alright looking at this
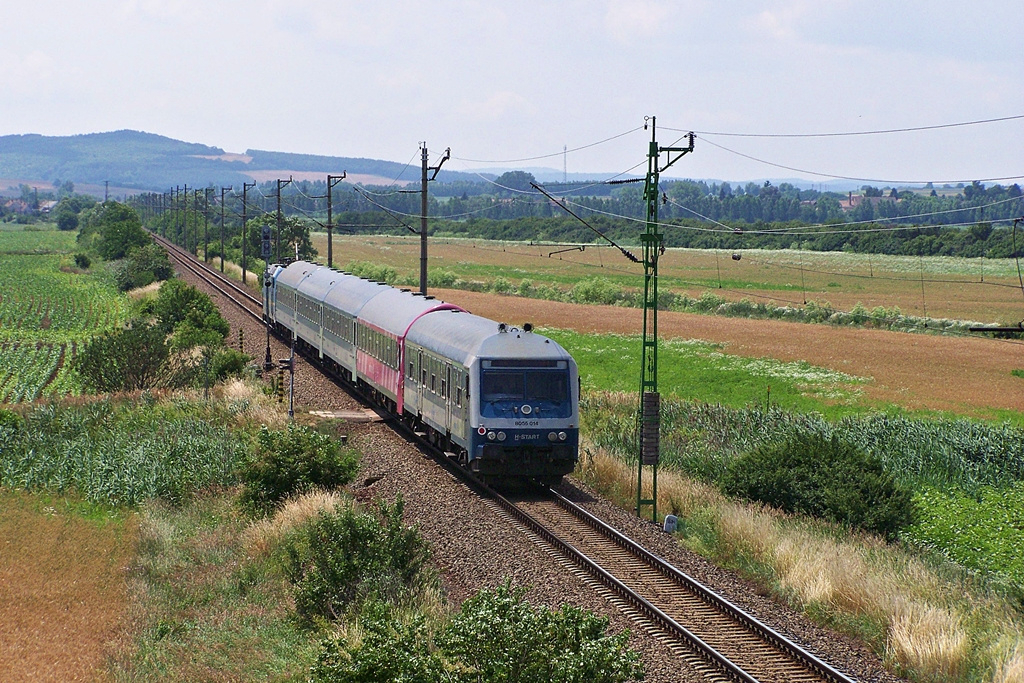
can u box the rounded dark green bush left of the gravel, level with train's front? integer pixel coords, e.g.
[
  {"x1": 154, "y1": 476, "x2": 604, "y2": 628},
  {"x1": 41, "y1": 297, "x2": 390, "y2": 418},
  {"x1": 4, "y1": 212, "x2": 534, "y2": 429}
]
[{"x1": 242, "y1": 425, "x2": 358, "y2": 513}]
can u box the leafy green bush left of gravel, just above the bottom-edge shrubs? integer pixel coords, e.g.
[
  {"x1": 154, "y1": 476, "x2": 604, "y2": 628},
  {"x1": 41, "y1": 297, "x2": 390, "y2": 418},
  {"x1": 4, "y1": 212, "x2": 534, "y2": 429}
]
[{"x1": 287, "y1": 497, "x2": 430, "y2": 622}]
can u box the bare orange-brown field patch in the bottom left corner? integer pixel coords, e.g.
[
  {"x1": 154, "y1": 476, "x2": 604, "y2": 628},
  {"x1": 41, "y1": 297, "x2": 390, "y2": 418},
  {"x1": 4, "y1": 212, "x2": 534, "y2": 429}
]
[{"x1": 0, "y1": 492, "x2": 133, "y2": 683}]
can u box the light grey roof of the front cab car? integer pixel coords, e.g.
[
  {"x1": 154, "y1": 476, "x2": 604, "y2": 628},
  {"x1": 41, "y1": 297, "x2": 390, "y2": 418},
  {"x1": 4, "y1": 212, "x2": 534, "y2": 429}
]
[{"x1": 407, "y1": 311, "x2": 571, "y2": 367}]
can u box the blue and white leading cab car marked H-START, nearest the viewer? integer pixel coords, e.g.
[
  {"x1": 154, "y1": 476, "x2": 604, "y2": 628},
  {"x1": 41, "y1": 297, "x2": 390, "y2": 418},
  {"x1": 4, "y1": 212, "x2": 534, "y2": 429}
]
[{"x1": 406, "y1": 313, "x2": 580, "y2": 485}]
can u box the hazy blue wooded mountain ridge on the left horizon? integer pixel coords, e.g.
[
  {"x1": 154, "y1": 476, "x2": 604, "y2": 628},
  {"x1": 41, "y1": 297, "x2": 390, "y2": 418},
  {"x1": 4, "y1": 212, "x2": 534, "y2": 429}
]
[{"x1": 0, "y1": 130, "x2": 480, "y2": 191}]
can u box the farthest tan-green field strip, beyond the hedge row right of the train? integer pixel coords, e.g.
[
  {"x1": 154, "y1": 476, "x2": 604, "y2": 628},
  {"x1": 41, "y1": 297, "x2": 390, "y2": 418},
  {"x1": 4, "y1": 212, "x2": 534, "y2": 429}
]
[{"x1": 312, "y1": 233, "x2": 1022, "y2": 323}]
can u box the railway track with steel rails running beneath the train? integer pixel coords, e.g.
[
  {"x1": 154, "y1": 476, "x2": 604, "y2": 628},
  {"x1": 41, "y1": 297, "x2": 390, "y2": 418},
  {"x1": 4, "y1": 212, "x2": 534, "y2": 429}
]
[{"x1": 155, "y1": 236, "x2": 854, "y2": 683}]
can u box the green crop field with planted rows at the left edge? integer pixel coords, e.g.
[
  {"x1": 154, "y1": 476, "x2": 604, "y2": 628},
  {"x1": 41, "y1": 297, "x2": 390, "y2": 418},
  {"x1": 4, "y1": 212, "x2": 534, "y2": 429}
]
[{"x1": 0, "y1": 229, "x2": 128, "y2": 403}]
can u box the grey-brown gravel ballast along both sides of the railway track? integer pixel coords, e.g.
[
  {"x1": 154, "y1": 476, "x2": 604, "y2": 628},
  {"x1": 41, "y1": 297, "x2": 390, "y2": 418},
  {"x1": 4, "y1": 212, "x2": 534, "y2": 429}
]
[{"x1": 181, "y1": 272, "x2": 902, "y2": 683}]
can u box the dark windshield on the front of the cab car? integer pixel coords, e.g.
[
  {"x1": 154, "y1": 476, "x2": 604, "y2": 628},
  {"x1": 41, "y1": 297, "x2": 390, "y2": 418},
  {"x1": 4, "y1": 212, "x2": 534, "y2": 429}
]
[{"x1": 480, "y1": 362, "x2": 572, "y2": 419}]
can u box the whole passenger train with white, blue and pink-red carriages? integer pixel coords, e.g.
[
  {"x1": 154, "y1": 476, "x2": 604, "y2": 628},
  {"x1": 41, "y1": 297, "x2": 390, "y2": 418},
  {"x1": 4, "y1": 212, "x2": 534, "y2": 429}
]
[{"x1": 263, "y1": 261, "x2": 580, "y2": 485}]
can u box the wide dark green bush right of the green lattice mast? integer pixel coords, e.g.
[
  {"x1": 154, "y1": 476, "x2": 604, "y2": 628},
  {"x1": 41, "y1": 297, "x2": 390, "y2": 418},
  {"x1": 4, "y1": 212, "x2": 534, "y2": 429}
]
[{"x1": 722, "y1": 433, "x2": 914, "y2": 539}]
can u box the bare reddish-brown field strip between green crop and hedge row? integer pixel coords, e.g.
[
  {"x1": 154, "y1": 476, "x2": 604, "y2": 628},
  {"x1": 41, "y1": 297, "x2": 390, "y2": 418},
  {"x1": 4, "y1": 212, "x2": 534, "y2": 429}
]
[{"x1": 430, "y1": 290, "x2": 1024, "y2": 416}]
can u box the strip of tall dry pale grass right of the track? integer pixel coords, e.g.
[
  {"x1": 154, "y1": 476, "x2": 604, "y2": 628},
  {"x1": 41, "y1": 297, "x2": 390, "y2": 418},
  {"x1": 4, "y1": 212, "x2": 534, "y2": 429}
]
[{"x1": 577, "y1": 446, "x2": 1024, "y2": 683}]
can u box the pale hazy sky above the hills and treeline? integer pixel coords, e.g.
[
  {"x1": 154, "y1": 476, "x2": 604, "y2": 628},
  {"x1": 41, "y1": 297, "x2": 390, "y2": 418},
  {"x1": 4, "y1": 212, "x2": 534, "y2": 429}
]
[{"x1": 0, "y1": 0, "x2": 1024, "y2": 186}]
